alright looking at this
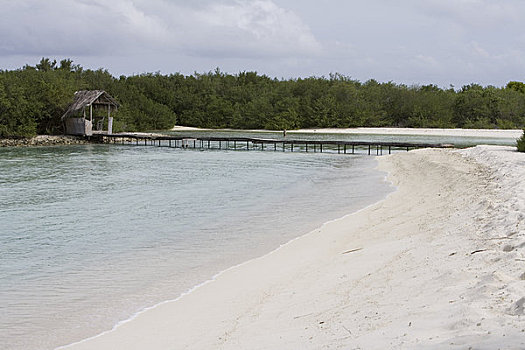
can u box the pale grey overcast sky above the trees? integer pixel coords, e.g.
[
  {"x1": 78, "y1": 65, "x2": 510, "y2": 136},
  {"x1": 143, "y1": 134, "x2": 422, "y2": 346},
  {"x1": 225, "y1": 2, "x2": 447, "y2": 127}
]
[{"x1": 0, "y1": 0, "x2": 525, "y2": 88}]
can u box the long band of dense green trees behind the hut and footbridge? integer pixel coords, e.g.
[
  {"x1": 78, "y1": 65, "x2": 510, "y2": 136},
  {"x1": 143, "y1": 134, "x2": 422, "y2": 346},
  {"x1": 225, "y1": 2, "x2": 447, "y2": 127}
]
[{"x1": 0, "y1": 58, "x2": 525, "y2": 137}]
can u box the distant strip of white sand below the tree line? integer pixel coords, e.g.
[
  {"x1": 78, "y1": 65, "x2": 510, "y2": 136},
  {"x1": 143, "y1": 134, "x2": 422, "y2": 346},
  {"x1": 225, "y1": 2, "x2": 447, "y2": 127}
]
[{"x1": 172, "y1": 126, "x2": 523, "y2": 139}]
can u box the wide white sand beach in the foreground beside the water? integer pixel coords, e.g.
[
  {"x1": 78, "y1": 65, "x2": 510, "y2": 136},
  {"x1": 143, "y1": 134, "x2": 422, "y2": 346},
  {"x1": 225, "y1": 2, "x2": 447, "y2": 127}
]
[{"x1": 62, "y1": 146, "x2": 525, "y2": 350}]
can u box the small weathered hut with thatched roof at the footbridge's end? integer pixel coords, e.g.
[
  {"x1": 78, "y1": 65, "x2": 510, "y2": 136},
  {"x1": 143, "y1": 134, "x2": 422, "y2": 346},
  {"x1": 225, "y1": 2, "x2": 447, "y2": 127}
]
[{"x1": 62, "y1": 90, "x2": 119, "y2": 136}]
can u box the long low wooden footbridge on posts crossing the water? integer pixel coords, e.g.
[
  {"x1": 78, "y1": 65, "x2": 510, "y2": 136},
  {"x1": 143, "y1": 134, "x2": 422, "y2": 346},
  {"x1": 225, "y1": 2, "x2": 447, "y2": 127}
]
[{"x1": 92, "y1": 133, "x2": 454, "y2": 155}]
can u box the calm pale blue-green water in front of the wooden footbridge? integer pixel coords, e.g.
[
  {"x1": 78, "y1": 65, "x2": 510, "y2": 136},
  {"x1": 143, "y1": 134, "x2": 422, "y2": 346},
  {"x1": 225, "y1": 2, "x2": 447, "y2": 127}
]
[{"x1": 0, "y1": 145, "x2": 393, "y2": 350}]
